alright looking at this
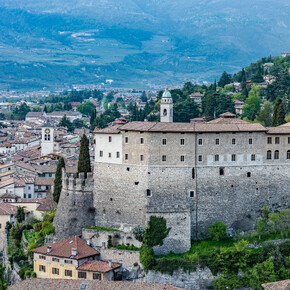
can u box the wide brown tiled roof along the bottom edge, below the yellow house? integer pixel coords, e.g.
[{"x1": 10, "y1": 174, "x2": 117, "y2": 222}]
[{"x1": 8, "y1": 278, "x2": 183, "y2": 290}]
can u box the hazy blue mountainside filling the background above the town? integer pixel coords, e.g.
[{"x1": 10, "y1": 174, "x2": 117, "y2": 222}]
[{"x1": 0, "y1": 0, "x2": 290, "y2": 88}]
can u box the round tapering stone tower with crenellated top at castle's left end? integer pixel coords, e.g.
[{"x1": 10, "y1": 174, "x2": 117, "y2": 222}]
[{"x1": 53, "y1": 170, "x2": 95, "y2": 241}]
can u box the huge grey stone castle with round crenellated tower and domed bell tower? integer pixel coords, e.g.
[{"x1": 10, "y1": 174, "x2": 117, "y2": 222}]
[{"x1": 55, "y1": 90, "x2": 290, "y2": 253}]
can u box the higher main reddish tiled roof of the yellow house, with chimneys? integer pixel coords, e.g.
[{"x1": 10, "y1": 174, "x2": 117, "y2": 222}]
[{"x1": 32, "y1": 236, "x2": 100, "y2": 260}]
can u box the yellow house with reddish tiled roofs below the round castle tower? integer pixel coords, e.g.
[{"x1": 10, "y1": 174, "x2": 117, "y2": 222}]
[{"x1": 32, "y1": 236, "x2": 121, "y2": 280}]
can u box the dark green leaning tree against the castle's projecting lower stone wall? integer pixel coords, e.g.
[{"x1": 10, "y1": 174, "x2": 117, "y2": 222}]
[{"x1": 143, "y1": 216, "x2": 171, "y2": 247}]
